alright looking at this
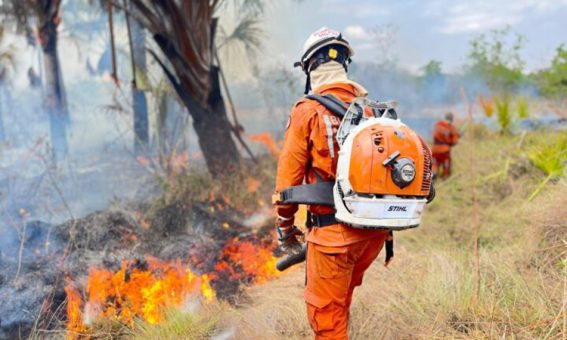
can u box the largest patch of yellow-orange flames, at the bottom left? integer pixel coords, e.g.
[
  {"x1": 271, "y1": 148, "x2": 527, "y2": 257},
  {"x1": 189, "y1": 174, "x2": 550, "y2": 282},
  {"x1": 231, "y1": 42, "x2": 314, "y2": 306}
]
[{"x1": 65, "y1": 257, "x2": 215, "y2": 334}]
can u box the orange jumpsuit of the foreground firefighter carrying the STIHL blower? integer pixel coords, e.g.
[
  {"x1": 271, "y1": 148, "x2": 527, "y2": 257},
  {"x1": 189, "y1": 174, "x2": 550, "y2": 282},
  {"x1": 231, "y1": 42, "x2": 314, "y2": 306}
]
[{"x1": 276, "y1": 83, "x2": 388, "y2": 339}]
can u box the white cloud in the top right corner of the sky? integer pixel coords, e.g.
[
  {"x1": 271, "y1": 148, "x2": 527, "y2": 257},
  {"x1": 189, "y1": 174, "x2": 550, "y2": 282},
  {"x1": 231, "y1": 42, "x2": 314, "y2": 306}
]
[{"x1": 423, "y1": 0, "x2": 567, "y2": 34}]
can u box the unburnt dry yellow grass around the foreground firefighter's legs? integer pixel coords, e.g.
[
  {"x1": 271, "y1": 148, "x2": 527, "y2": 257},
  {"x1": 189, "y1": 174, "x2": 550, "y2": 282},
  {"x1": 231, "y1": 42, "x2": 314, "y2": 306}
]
[{"x1": 129, "y1": 129, "x2": 567, "y2": 339}]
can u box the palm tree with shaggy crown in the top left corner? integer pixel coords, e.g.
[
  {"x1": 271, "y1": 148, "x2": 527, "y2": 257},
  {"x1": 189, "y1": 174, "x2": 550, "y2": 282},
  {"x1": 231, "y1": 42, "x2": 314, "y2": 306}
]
[{"x1": 0, "y1": 0, "x2": 69, "y2": 160}]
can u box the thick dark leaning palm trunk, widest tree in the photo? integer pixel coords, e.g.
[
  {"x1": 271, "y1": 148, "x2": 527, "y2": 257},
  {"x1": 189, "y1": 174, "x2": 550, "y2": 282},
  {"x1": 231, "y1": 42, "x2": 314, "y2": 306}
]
[{"x1": 131, "y1": 0, "x2": 261, "y2": 177}]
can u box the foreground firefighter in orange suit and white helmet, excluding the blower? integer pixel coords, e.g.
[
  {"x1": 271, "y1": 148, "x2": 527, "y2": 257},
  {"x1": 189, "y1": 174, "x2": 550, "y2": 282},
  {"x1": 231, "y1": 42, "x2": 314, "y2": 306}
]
[{"x1": 276, "y1": 27, "x2": 390, "y2": 339}]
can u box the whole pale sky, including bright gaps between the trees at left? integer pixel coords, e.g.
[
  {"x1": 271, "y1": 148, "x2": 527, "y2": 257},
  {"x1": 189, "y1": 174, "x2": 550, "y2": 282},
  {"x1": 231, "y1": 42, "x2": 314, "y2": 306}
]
[{"x1": 2, "y1": 0, "x2": 567, "y2": 88}]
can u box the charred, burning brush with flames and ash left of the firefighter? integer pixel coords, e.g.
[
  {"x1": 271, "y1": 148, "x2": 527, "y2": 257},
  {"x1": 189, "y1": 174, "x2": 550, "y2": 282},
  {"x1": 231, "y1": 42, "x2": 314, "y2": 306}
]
[{"x1": 0, "y1": 157, "x2": 278, "y2": 339}]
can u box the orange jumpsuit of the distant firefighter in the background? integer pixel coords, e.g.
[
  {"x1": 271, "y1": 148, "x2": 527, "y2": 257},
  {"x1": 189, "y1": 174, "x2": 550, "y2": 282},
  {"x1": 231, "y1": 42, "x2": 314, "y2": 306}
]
[{"x1": 431, "y1": 120, "x2": 459, "y2": 178}]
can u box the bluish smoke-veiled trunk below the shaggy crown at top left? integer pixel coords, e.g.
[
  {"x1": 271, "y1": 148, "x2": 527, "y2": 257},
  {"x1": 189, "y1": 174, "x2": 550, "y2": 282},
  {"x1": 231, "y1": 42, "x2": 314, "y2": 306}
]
[{"x1": 41, "y1": 22, "x2": 69, "y2": 161}]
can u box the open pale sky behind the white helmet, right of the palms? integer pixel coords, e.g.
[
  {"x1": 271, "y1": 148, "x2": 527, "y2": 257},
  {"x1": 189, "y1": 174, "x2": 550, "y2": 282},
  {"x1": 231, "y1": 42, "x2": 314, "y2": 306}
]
[{"x1": 264, "y1": 0, "x2": 567, "y2": 73}]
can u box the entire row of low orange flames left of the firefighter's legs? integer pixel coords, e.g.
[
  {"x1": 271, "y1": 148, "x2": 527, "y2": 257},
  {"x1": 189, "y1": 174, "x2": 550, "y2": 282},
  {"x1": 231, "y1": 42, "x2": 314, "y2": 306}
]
[{"x1": 65, "y1": 238, "x2": 278, "y2": 338}]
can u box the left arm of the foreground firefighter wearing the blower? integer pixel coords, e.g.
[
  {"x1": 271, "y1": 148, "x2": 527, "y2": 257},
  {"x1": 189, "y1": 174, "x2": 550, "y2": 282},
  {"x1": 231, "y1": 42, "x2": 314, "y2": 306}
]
[{"x1": 276, "y1": 103, "x2": 313, "y2": 227}]
